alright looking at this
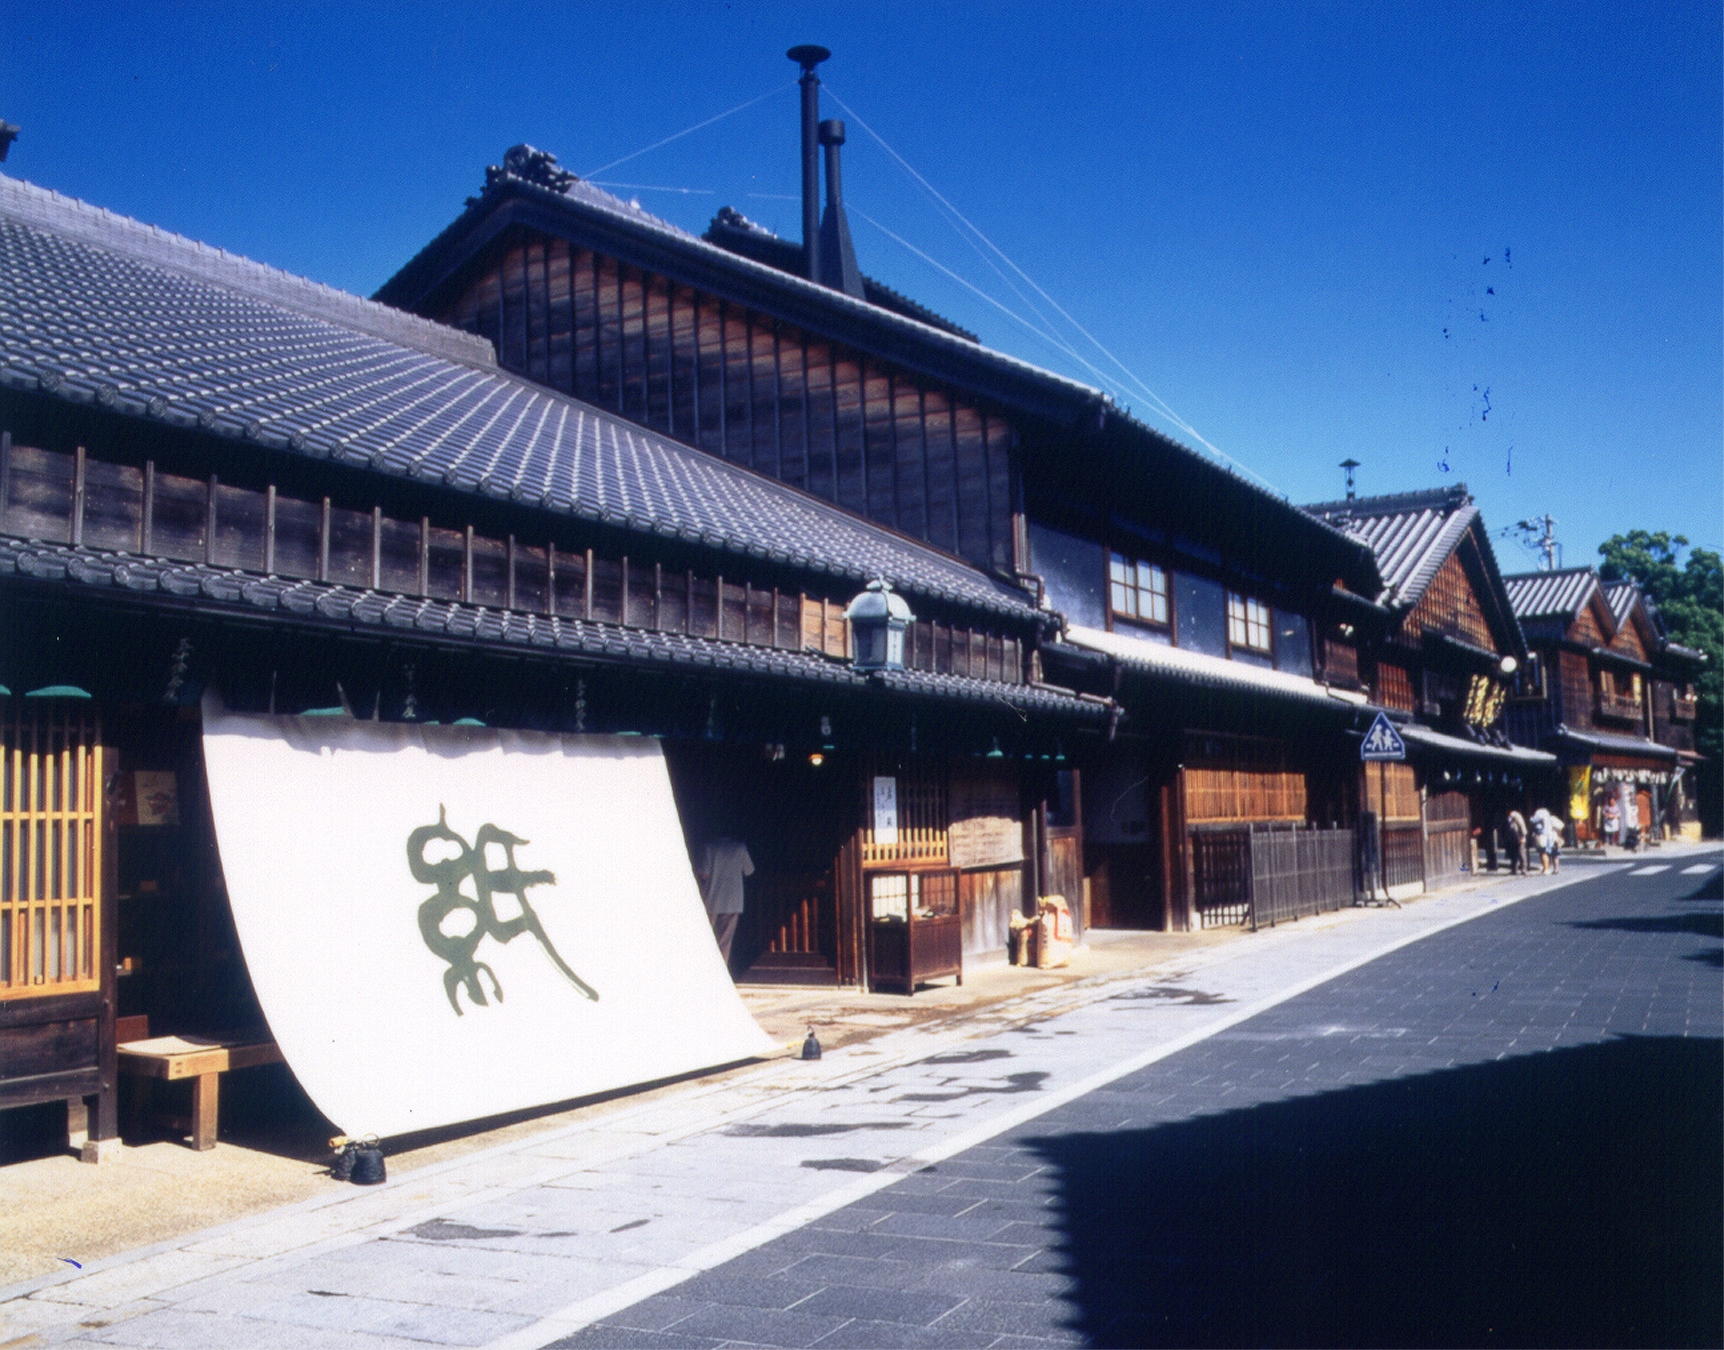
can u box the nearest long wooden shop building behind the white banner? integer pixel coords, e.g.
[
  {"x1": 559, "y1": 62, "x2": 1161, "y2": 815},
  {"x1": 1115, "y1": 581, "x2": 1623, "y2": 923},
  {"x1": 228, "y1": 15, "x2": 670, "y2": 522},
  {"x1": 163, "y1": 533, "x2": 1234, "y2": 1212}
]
[{"x1": 0, "y1": 178, "x2": 1115, "y2": 1158}]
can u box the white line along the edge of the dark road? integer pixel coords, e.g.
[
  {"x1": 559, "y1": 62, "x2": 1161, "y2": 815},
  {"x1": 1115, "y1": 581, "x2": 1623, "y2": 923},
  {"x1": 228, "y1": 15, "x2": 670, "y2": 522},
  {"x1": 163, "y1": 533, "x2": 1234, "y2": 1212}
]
[{"x1": 484, "y1": 872, "x2": 1598, "y2": 1350}]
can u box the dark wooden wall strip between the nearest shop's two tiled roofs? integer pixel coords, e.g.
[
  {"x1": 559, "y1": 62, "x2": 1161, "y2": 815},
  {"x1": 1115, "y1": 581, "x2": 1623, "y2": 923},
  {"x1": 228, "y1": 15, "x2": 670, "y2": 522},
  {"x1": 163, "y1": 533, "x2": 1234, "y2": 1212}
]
[{"x1": 0, "y1": 433, "x2": 1024, "y2": 684}]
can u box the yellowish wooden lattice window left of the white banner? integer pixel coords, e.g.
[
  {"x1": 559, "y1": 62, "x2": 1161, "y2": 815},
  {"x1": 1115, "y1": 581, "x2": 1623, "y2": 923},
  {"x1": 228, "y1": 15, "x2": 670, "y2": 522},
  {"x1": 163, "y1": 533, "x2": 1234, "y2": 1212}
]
[{"x1": 0, "y1": 702, "x2": 103, "y2": 1000}]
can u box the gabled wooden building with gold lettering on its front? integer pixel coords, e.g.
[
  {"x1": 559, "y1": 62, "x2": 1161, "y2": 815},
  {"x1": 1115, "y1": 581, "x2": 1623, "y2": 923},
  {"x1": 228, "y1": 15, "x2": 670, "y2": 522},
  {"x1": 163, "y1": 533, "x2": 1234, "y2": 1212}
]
[{"x1": 1307, "y1": 483, "x2": 1555, "y2": 886}]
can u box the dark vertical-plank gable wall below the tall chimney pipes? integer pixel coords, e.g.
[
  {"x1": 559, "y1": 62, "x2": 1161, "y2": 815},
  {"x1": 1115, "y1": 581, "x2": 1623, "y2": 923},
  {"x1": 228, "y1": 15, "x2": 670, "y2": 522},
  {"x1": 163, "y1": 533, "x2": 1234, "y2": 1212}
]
[{"x1": 429, "y1": 229, "x2": 1014, "y2": 571}]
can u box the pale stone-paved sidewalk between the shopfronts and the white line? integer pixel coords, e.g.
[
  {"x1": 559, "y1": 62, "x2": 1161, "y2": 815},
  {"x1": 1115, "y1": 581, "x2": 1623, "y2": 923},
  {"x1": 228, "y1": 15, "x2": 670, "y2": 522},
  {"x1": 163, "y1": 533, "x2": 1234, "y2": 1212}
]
[{"x1": 0, "y1": 867, "x2": 1710, "y2": 1350}]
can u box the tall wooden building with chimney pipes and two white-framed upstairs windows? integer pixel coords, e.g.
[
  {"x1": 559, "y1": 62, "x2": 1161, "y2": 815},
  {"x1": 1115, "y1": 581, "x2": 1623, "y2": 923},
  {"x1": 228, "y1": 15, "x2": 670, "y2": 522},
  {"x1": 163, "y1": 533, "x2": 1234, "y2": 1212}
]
[{"x1": 376, "y1": 145, "x2": 1381, "y2": 928}]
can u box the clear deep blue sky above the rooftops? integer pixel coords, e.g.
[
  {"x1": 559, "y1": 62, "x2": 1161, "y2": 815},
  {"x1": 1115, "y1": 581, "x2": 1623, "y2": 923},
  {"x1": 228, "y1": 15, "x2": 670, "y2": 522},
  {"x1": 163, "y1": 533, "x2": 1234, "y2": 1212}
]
[{"x1": 0, "y1": 0, "x2": 1724, "y2": 571}]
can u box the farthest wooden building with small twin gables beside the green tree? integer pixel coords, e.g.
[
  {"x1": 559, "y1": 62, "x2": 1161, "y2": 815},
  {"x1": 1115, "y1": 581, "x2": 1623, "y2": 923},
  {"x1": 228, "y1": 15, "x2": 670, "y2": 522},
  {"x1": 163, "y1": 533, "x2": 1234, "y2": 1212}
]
[{"x1": 1507, "y1": 567, "x2": 1681, "y2": 843}]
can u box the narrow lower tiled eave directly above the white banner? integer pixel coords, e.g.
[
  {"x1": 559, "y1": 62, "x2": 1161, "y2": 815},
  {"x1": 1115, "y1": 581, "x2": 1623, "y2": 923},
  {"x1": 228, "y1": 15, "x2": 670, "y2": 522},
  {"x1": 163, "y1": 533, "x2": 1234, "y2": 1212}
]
[{"x1": 0, "y1": 538, "x2": 1107, "y2": 719}]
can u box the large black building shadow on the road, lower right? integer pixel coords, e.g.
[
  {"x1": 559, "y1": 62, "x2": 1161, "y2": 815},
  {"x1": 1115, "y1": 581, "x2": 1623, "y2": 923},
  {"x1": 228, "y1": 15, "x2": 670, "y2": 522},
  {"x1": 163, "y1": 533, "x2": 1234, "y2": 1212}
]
[{"x1": 1026, "y1": 1036, "x2": 1724, "y2": 1347}]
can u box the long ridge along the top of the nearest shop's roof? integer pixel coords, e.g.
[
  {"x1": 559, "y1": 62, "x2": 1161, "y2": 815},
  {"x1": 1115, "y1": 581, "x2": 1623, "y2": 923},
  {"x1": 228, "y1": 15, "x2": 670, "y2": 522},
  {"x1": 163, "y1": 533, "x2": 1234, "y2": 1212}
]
[{"x1": 0, "y1": 174, "x2": 497, "y2": 369}]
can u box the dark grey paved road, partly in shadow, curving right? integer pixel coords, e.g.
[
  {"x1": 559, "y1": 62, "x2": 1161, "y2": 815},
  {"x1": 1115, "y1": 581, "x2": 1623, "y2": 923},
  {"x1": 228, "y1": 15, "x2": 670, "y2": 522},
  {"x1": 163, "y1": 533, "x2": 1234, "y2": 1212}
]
[{"x1": 559, "y1": 855, "x2": 1724, "y2": 1350}]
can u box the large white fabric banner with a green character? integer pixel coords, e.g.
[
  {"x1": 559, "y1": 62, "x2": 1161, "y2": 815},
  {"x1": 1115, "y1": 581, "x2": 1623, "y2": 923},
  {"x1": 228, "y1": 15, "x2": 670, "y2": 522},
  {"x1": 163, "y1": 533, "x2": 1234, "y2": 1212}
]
[{"x1": 203, "y1": 698, "x2": 774, "y2": 1136}]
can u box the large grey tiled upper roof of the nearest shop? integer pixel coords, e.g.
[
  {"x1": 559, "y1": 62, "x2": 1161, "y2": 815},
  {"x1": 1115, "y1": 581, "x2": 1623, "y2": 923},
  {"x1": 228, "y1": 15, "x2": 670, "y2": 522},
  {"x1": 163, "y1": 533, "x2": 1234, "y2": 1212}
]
[{"x1": 0, "y1": 178, "x2": 1034, "y2": 619}]
